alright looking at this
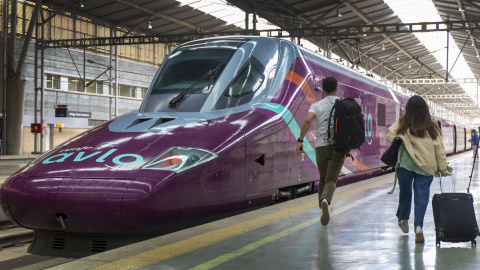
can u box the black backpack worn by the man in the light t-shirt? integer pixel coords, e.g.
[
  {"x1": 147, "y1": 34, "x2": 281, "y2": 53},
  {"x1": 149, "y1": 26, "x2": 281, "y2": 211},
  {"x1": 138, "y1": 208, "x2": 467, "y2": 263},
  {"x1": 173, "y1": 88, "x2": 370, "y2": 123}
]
[{"x1": 327, "y1": 98, "x2": 365, "y2": 159}]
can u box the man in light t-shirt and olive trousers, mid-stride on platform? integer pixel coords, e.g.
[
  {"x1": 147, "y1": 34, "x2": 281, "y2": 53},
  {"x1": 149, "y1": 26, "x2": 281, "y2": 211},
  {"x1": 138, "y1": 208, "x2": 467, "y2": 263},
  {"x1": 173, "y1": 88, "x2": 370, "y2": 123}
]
[{"x1": 297, "y1": 77, "x2": 345, "y2": 226}]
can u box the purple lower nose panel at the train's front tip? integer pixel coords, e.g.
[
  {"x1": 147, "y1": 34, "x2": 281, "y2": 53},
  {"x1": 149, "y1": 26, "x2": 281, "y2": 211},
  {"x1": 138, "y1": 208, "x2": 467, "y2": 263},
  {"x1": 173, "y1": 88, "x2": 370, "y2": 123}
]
[{"x1": 6, "y1": 177, "x2": 132, "y2": 233}]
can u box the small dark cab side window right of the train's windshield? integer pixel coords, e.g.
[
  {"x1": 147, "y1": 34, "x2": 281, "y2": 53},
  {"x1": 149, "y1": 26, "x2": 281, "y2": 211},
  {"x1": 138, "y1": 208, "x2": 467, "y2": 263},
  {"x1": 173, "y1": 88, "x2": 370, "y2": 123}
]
[{"x1": 225, "y1": 63, "x2": 263, "y2": 98}]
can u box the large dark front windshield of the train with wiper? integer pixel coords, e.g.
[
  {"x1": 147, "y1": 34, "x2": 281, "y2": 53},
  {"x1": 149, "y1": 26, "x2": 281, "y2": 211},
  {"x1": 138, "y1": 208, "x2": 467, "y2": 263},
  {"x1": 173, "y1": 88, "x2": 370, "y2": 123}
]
[{"x1": 144, "y1": 47, "x2": 235, "y2": 112}]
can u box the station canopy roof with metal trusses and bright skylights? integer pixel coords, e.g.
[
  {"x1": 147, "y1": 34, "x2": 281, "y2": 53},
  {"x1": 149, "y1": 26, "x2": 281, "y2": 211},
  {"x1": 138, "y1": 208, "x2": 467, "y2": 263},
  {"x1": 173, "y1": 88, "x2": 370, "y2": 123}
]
[{"x1": 39, "y1": 0, "x2": 480, "y2": 122}]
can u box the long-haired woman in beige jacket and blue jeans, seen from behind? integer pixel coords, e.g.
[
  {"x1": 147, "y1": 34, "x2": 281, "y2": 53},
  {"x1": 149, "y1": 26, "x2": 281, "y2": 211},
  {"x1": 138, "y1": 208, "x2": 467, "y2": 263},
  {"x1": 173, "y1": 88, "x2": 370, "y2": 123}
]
[{"x1": 387, "y1": 96, "x2": 451, "y2": 243}]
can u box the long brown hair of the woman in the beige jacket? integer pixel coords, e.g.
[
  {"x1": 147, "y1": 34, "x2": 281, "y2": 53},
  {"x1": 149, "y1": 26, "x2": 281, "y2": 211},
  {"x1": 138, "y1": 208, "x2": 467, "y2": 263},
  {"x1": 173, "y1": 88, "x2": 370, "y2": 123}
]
[{"x1": 397, "y1": 96, "x2": 440, "y2": 140}]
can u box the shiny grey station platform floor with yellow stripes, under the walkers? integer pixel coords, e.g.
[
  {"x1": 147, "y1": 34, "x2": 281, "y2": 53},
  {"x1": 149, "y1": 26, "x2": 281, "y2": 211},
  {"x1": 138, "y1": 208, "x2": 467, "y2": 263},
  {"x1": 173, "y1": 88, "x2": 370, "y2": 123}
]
[{"x1": 35, "y1": 152, "x2": 480, "y2": 270}]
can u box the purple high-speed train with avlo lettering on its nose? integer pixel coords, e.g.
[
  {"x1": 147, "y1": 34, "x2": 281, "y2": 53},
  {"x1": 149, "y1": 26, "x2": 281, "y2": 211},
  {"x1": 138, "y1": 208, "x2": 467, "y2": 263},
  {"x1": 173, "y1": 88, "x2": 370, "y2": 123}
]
[{"x1": 0, "y1": 36, "x2": 471, "y2": 257}]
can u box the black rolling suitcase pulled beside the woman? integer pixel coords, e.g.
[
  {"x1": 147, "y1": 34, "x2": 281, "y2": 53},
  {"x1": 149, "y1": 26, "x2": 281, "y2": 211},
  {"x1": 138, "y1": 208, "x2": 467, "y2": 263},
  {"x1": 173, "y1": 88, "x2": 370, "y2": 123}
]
[{"x1": 432, "y1": 175, "x2": 478, "y2": 247}]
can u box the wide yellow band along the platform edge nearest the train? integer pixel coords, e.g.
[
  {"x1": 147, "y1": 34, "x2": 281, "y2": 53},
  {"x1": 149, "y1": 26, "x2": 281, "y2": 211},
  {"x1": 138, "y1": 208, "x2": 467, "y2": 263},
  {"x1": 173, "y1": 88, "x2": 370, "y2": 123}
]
[{"x1": 92, "y1": 177, "x2": 392, "y2": 270}]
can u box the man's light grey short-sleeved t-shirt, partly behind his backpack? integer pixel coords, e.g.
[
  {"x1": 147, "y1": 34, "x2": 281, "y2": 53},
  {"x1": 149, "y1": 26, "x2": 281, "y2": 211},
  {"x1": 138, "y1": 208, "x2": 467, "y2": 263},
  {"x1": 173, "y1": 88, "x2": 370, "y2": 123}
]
[{"x1": 308, "y1": 96, "x2": 339, "y2": 147}]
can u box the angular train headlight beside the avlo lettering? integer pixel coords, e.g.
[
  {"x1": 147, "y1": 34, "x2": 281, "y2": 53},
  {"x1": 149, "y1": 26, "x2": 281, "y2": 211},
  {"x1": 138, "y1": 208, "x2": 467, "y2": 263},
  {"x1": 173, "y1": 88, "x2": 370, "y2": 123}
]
[{"x1": 142, "y1": 147, "x2": 218, "y2": 173}]
